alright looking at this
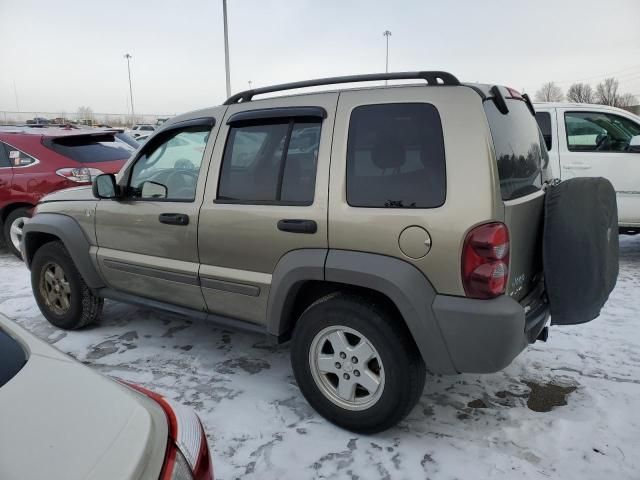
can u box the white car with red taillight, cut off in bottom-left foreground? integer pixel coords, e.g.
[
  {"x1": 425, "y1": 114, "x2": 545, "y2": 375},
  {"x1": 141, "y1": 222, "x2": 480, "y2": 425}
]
[{"x1": 0, "y1": 314, "x2": 213, "y2": 480}]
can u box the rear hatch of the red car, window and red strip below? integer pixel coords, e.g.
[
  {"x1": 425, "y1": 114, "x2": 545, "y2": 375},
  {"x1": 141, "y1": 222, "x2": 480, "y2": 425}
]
[{"x1": 43, "y1": 132, "x2": 136, "y2": 173}]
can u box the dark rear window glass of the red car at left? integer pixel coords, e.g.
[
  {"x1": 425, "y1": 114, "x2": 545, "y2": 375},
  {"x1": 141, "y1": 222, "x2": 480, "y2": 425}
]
[{"x1": 45, "y1": 134, "x2": 135, "y2": 163}]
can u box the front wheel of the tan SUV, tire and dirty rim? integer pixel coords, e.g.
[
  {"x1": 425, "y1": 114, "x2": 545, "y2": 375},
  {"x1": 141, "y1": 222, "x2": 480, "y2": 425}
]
[{"x1": 31, "y1": 242, "x2": 103, "y2": 330}]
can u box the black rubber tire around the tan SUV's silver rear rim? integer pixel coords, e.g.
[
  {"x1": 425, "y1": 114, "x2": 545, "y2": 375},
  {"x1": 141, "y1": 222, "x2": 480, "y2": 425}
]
[{"x1": 291, "y1": 293, "x2": 426, "y2": 434}]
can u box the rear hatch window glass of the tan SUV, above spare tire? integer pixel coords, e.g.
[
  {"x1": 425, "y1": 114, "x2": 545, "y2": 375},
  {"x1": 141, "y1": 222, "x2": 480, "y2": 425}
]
[{"x1": 484, "y1": 99, "x2": 549, "y2": 200}]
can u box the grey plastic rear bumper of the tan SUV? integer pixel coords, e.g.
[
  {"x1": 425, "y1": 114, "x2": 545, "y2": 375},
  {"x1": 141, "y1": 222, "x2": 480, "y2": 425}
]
[{"x1": 433, "y1": 291, "x2": 549, "y2": 373}]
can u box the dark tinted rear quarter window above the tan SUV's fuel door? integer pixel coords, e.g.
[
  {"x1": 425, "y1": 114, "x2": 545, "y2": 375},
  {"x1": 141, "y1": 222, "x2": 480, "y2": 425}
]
[{"x1": 347, "y1": 103, "x2": 446, "y2": 208}]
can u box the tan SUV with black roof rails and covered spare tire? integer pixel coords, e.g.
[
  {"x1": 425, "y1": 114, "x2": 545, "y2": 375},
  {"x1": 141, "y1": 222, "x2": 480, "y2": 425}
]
[{"x1": 22, "y1": 72, "x2": 617, "y2": 433}]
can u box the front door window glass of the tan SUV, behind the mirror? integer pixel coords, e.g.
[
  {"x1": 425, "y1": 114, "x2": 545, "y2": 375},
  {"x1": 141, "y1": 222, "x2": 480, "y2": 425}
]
[{"x1": 129, "y1": 126, "x2": 210, "y2": 201}]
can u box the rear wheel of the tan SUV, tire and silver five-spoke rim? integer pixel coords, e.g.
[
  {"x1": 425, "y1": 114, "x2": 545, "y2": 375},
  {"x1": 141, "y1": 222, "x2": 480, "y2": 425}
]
[{"x1": 291, "y1": 293, "x2": 426, "y2": 434}]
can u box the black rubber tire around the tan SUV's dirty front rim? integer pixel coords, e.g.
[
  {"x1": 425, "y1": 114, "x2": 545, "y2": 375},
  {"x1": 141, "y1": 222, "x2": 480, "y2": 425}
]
[{"x1": 31, "y1": 242, "x2": 104, "y2": 330}]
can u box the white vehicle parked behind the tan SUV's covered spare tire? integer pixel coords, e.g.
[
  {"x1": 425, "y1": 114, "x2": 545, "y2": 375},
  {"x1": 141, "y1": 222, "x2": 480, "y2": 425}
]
[{"x1": 535, "y1": 103, "x2": 640, "y2": 234}]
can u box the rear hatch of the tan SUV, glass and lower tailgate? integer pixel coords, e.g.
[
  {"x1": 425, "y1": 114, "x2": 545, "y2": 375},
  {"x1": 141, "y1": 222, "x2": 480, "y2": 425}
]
[{"x1": 484, "y1": 88, "x2": 549, "y2": 300}]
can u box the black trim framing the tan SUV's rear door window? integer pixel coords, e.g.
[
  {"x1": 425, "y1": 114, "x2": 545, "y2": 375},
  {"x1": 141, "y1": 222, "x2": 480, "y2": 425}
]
[{"x1": 213, "y1": 117, "x2": 326, "y2": 207}]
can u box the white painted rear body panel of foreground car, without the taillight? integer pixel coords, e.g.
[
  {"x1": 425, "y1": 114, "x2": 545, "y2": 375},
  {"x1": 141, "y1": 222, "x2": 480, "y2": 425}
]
[{"x1": 0, "y1": 316, "x2": 168, "y2": 480}]
